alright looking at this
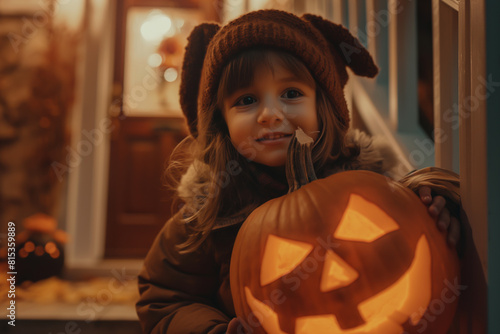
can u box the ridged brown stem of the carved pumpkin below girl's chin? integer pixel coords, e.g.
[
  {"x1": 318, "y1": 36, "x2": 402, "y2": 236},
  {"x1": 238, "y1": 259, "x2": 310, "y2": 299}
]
[{"x1": 286, "y1": 128, "x2": 318, "y2": 193}]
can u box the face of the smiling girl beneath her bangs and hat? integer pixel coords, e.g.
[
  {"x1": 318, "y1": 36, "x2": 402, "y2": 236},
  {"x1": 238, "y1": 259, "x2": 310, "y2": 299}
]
[{"x1": 223, "y1": 58, "x2": 319, "y2": 167}]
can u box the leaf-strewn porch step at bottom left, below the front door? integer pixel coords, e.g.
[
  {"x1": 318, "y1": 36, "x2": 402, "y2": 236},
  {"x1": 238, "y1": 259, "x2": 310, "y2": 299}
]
[{"x1": 0, "y1": 261, "x2": 141, "y2": 334}]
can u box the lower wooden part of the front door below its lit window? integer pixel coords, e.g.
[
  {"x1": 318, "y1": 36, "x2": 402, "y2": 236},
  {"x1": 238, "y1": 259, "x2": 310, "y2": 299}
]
[{"x1": 105, "y1": 117, "x2": 186, "y2": 258}]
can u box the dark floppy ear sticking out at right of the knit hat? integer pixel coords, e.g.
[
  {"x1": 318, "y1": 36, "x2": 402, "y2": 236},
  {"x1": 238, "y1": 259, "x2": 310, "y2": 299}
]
[{"x1": 302, "y1": 14, "x2": 378, "y2": 86}]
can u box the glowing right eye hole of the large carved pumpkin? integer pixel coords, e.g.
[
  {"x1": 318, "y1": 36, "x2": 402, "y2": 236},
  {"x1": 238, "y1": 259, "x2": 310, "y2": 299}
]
[{"x1": 333, "y1": 194, "x2": 399, "y2": 242}]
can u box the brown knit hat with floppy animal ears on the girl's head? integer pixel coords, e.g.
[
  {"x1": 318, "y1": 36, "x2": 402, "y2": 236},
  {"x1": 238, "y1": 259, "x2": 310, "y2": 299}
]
[{"x1": 180, "y1": 10, "x2": 378, "y2": 137}]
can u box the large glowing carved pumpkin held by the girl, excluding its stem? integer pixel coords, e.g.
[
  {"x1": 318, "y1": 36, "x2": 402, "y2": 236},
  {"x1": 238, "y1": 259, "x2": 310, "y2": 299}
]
[{"x1": 230, "y1": 171, "x2": 459, "y2": 334}]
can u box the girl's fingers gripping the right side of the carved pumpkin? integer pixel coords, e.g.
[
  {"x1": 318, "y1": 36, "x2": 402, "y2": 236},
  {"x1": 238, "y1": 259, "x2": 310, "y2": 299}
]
[{"x1": 418, "y1": 186, "x2": 460, "y2": 246}]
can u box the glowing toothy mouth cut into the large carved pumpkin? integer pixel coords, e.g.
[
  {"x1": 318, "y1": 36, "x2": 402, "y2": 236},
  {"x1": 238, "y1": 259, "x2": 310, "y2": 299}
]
[{"x1": 245, "y1": 236, "x2": 431, "y2": 334}]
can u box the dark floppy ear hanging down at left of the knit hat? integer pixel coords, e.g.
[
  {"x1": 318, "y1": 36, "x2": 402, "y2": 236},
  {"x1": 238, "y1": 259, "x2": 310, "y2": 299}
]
[{"x1": 179, "y1": 23, "x2": 220, "y2": 137}]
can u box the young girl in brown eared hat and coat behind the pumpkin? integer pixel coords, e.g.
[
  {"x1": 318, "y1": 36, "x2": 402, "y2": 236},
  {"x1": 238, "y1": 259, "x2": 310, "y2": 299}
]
[{"x1": 137, "y1": 10, "x2": 458, "y2": 334}]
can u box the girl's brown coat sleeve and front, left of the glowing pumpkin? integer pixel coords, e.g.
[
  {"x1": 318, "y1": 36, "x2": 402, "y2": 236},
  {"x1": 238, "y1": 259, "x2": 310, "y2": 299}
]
[{"x1": 137, "y1": 216, "x2": 239, "y2": 334}]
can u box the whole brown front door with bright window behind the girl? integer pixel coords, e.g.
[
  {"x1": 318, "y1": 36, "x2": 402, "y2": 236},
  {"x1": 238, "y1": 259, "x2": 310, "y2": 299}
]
[{"x1": 105, "y1": 0, "x2": 219, "y2": 258}]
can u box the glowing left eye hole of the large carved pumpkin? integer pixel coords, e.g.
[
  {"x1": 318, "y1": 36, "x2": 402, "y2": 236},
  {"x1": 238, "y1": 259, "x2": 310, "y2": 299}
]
[{"x1": 260, "y1": 234, "x2": 313, "y2": 286}]
